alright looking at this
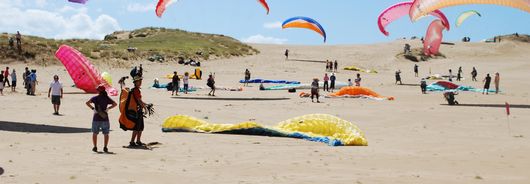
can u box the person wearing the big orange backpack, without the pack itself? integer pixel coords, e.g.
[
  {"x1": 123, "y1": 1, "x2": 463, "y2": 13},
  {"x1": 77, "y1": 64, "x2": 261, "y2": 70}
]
[{"x1": 129, "y1": 76, "x2": 147, "y2": 147}]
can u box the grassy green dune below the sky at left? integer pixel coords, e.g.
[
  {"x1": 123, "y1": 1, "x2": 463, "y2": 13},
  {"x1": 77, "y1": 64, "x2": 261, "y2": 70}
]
[{"x1": 0, "y1": 28, "x2": 259, "y2": 63}]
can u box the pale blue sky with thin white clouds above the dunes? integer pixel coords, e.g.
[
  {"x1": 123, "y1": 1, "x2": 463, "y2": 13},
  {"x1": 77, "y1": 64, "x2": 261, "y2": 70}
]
[{"x1": 0, "y1": 0, "x2": 530, "y2": 45}]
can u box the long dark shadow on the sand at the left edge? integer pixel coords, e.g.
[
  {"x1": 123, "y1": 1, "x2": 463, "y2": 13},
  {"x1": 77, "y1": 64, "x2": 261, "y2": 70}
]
[{"x1": 0, "y1": 121, "x2": 92, "y2": 134}]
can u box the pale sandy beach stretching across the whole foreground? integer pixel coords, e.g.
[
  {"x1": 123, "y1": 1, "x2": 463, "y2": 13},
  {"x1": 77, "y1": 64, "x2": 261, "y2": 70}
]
[{"x1": 0, "y1": 40, "x2": 530, "y2": 184}]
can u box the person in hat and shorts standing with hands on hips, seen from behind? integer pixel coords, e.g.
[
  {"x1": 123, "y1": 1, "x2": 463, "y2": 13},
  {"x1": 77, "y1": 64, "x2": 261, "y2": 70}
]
[{"x1": 86, "y1": 86, "x2": 118, "y2": 153}]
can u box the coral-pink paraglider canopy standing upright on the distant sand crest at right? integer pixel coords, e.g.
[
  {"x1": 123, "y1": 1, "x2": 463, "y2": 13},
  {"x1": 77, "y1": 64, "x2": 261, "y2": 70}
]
[{"x1": 423, "y1": 19, "x2": 445, "y2": 56}]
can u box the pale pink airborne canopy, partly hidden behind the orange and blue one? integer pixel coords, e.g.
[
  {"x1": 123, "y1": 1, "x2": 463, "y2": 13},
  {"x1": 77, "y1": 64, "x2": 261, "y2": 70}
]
[{"x1": 377, "y1": 2, "x2": 450, "y2": 36}]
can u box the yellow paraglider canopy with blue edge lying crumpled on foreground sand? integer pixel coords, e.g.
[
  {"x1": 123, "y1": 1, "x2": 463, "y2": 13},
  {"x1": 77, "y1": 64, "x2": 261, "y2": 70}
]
[{"x1": 162, "y1": 114, "x2": 368, "y2": 146}]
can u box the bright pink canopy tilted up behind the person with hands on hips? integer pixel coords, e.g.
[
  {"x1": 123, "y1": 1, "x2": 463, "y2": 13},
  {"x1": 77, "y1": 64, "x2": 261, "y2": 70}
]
[{"x1": 55, "y1": 45, "x2": 118, "y2": 96}]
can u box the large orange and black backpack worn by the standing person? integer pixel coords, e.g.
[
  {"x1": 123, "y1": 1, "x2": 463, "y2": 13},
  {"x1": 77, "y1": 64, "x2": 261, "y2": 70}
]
[{"x1": 119, "y1": 88, "x2": 143, "y2": 131}]
